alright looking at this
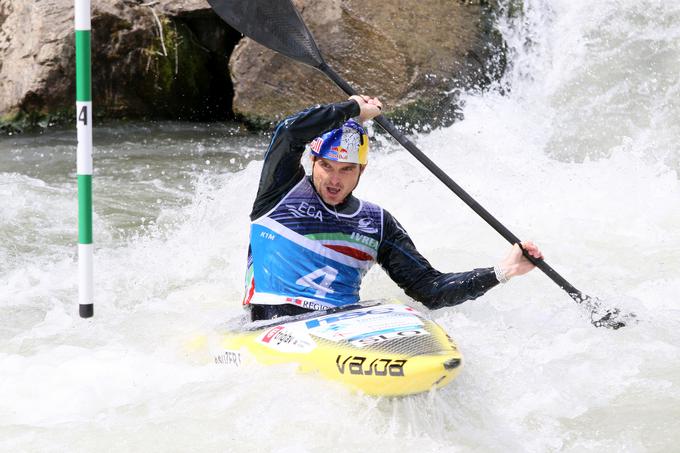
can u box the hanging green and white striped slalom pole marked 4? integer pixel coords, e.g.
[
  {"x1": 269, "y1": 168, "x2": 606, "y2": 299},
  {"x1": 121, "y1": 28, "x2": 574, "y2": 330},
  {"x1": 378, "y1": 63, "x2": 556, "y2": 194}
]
[{"x1": 75, "y1": 0, "x2": 94, "y2": 318}]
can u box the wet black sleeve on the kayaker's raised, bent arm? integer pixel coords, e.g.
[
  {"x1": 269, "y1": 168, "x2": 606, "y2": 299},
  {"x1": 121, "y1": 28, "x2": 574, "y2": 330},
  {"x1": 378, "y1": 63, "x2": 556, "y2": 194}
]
[{"x1": 250, "y1": 101, "x2": 359, "y2": 220}]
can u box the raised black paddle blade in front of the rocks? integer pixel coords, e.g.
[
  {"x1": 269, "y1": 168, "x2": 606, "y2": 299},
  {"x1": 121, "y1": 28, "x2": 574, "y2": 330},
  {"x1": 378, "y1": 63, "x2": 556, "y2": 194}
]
[{"x1": 208, "y1": 0, "x2": 324, "y2": 68}]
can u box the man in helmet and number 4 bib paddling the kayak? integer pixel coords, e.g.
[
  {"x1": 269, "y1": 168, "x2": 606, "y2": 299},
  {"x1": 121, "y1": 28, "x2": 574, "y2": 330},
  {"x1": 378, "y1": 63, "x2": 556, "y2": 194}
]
[{"x1": 243, "y1": 96, "x2": 542, "y2": 321}]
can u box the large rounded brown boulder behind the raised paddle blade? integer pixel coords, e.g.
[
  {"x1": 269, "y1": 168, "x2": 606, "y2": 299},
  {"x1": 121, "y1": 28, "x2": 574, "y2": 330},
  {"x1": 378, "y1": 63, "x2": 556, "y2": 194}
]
[{"x1": 229, "y1": 0, "x2": 504, "y2": 129}]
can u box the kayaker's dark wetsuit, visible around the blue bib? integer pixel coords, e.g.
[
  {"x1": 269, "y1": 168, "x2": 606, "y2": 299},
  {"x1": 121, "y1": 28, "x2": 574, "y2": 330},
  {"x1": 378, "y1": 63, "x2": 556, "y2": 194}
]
[{"x1": 249, "y1": 101, "x2": 498, "y2": 320}]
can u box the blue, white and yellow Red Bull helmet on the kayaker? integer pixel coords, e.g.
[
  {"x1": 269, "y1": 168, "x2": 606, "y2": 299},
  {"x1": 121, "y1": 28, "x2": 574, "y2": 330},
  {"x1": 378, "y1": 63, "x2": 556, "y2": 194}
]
[{"x1": 309, "y1": 120, "x2": 368, "y2": 165}]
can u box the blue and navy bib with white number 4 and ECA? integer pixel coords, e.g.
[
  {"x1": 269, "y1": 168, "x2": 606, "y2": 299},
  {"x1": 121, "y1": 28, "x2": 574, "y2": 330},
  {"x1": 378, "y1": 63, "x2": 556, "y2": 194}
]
[{"x1": 243, "y1": 178, "x2": 383, "y2": 310}]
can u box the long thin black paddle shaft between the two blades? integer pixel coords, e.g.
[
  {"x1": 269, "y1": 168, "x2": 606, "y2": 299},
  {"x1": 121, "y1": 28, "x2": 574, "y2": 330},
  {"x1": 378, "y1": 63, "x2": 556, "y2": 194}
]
[{"x1": 317, "y1": 63, "x2": 584, "y2": 303}]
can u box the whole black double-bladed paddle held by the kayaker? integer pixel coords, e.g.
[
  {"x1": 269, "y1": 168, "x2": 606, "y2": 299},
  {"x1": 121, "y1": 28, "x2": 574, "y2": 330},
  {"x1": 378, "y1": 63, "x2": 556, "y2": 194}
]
[{"x1": 208, "y1": 0, "x2": 634, "y2": 329}]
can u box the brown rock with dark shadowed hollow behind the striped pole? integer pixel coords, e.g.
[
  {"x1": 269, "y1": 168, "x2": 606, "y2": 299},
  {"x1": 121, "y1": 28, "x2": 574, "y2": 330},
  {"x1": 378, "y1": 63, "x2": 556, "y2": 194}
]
[{"x1": 0, "y1": 0, "x2": 240, "y2": 131}]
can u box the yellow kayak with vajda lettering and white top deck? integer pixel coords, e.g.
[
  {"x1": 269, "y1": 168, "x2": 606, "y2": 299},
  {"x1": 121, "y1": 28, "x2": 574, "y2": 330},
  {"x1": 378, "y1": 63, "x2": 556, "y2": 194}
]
[{"x1": 189, "y1": 302, "x2": 462, "y2": 396}]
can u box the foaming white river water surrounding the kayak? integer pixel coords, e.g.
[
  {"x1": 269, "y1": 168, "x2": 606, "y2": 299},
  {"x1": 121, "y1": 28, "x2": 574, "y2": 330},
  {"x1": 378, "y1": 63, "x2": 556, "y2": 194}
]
[{"x1": 0, "y1": 0, "x2": 680, "y2": 452}]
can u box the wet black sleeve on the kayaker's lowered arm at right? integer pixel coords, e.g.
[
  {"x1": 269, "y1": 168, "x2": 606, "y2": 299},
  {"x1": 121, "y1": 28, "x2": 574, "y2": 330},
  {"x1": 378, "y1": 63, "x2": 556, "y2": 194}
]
[{"x1": 378, "y1": 211, "x2": 498, "y2": 309}]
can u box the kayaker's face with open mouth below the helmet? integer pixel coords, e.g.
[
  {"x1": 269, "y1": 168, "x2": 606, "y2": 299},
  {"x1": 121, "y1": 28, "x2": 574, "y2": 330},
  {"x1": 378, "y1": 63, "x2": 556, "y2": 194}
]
[{"x1": 312, "y1": 157, "x2": 364, "y2": 206}]
